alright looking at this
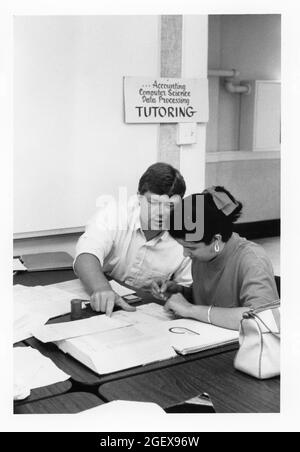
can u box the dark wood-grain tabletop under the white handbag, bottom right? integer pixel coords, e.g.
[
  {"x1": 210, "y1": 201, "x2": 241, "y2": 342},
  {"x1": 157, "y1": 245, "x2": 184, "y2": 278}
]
[{"x1": 99, "y1": 352, "x2": 280, "y2": 413}]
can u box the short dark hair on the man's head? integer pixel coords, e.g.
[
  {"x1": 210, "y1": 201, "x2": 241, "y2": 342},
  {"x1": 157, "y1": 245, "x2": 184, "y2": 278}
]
[{"x1": 138, "y1": 162, "x2": 186, "y2": 197}]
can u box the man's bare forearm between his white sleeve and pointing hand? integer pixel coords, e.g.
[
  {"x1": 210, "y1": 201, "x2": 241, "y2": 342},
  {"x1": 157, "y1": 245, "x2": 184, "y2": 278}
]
[{"x1": 74, "y1": 253, "x2": 111, "y2": 295}]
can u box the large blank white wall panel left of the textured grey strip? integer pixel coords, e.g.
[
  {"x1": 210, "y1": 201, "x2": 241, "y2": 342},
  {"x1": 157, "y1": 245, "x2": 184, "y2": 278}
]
[{"x1": 14, "y1": 16, "x2": 159, "y2": 233}]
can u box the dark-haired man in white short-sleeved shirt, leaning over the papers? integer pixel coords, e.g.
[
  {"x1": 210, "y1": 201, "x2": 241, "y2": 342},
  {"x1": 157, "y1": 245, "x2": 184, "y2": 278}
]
[{"x1": 74, "y1": 163, "x2": 192, "y2": 316}]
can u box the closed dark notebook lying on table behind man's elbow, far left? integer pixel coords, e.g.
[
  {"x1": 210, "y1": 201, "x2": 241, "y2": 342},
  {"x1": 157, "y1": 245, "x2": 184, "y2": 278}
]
[{"x1": 14, "y1": 251, "x2": 73, "y2": 272}]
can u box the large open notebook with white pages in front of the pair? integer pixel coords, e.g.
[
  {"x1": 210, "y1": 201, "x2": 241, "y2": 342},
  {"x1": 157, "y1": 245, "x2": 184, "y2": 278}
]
[{"x1": 55, "y1": 303, "x2": 239, "y2": 375}]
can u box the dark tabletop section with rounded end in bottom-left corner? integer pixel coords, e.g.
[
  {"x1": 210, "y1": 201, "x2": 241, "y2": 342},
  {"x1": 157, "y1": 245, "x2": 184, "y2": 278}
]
[{"x1": 14, "y1": 392, "x2": 104, "y2": 414}]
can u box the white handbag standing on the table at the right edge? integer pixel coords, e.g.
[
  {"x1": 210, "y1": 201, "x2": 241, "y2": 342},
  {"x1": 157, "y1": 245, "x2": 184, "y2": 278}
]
[{"x1": 234, "y1": 300, "x2": 280, "y2": 380}]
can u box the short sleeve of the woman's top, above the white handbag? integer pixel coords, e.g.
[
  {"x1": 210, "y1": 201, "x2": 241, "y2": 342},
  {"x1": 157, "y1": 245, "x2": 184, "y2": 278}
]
[{"x1": 239, "y1": 255, "x2": 279, "y2": 308}]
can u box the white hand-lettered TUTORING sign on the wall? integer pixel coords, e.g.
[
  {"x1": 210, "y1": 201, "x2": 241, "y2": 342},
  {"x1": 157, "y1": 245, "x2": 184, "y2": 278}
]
[{"x1": 124, "y1": 77, "x2": 208, "y2": 123}]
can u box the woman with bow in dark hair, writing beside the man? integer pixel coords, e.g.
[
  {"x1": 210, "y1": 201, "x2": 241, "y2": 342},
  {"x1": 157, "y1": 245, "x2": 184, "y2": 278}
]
[{"x1": 152, "y1": 187, "x2": 278, "y2": 330}]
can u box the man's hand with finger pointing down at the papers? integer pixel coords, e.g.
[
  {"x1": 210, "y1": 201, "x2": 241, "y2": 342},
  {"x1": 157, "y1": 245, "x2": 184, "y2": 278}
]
[{"x1": 91, "y1": 289, "x2": 136, "y2": 317}]
